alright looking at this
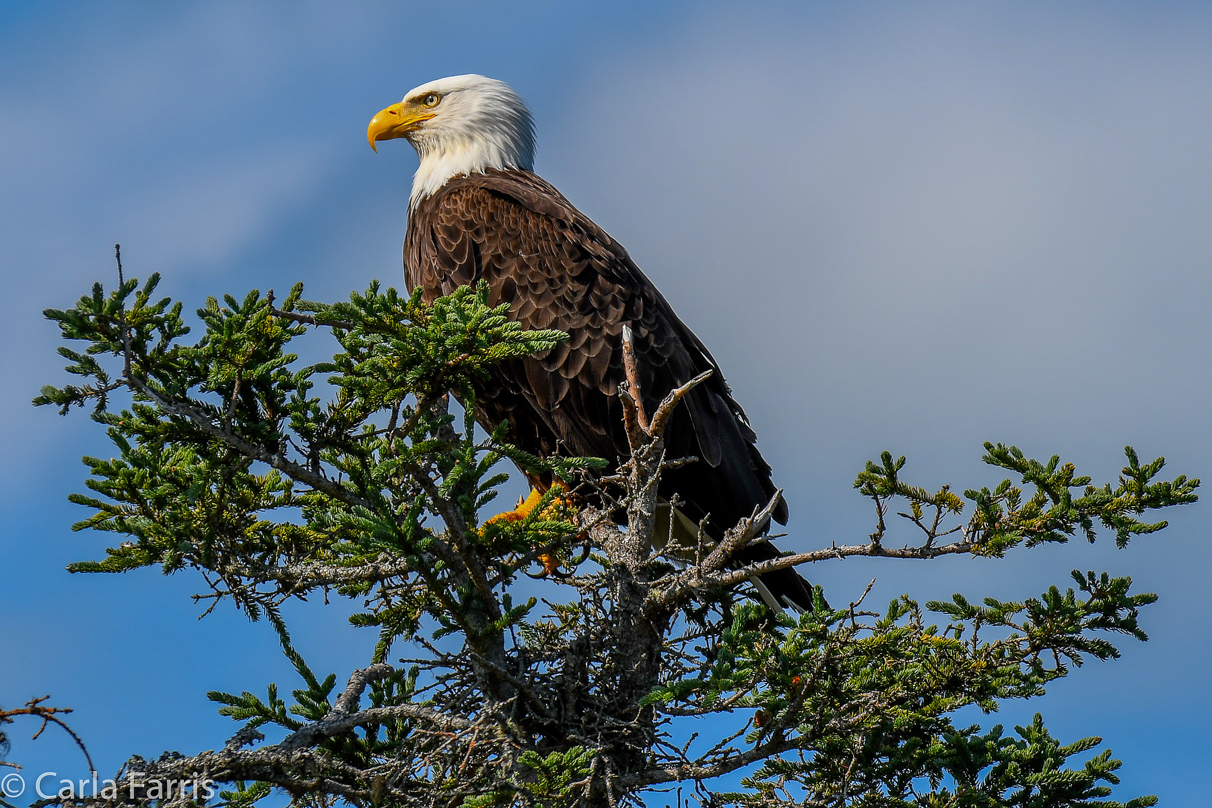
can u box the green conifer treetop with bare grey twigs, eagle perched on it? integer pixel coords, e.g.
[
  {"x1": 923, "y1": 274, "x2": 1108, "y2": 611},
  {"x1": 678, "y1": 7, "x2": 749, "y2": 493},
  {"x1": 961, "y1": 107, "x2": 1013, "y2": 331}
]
[{"x1": 37, "y1": 278, "x2": 1182, "y2": 808}]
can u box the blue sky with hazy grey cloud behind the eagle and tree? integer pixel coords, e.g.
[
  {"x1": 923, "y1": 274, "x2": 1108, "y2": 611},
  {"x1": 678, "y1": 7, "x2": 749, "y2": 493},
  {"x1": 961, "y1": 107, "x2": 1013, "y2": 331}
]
[{"x1": 0, "y1": 1, "x2": 1212, "y2": 804}]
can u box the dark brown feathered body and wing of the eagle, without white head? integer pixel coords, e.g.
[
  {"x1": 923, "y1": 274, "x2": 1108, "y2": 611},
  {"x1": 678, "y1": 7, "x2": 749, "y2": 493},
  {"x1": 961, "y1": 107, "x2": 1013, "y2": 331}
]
[{"x1": 404, "y1": 171, "x2": 814, "y2": 612}]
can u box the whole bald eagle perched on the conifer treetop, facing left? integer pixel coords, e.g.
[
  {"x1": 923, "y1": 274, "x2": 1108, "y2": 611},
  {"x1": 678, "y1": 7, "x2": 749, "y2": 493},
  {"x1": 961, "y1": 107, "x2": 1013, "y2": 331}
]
[{"x1": 366, "y1": 75, "x2": 812, "y2": 611}]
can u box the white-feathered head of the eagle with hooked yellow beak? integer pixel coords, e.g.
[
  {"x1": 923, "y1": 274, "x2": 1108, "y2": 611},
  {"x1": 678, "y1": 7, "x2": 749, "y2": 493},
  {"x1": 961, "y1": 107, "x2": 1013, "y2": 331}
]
[{"x1": 366, "y1": 73, "x2": 534, "y2": 207}]
